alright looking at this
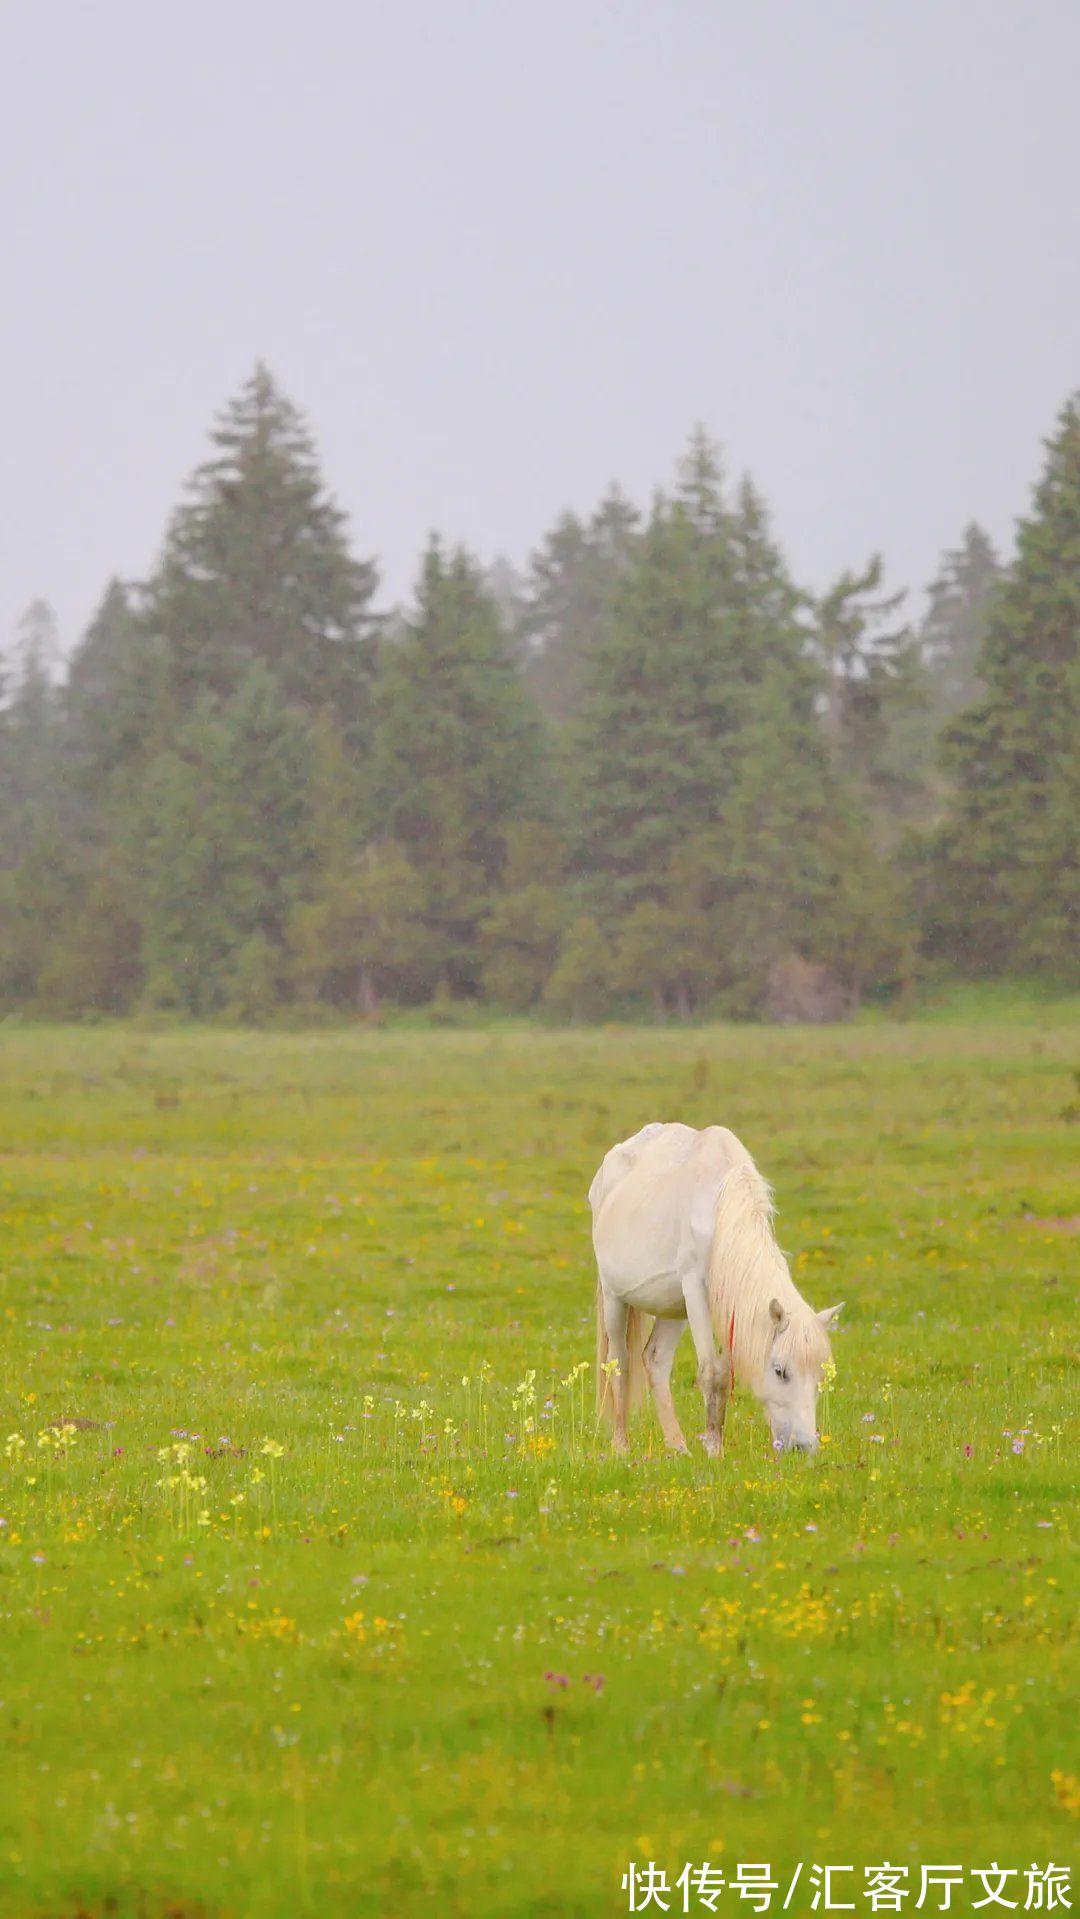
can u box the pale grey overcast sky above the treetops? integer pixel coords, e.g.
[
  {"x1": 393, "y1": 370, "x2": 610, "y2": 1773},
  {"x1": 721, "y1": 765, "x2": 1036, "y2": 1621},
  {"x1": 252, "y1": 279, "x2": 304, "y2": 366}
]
[{"x1": 0, "y1": 0, "x2": 1080, "y2": 645}]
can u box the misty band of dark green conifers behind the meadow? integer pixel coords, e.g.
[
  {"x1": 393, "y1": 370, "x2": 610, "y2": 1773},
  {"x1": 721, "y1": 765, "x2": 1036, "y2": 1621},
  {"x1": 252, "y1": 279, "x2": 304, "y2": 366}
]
[{"x1": 0, "y1": 367, "x2": 1080, "y2": 1021}]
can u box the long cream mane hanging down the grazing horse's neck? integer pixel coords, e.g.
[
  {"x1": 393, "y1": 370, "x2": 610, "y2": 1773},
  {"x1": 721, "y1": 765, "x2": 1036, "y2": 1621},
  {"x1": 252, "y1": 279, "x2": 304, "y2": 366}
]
[{"x1": 708, "y1": 1142, "x2": 831, "y2": 1386}]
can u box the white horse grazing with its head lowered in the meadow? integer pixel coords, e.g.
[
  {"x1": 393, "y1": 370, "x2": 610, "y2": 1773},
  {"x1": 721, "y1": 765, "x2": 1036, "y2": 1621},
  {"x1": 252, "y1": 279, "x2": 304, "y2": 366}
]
[{"x1": 589, "y1": 1121, "x2": 840, "y2": 1455}]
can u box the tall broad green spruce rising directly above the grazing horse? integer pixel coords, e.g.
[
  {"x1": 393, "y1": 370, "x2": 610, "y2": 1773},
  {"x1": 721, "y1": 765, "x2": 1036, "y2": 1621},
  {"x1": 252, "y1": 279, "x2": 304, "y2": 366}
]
[{"x1": 577, "y1": 434, "x2": 905, "y2": 1013}]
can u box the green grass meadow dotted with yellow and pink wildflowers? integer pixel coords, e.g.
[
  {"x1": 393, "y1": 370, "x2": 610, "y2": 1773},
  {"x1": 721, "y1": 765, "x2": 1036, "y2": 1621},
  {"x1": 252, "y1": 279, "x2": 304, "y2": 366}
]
[{"x1": 0, "y1": 1028, "x2": 1080, "y2": 1919}]
